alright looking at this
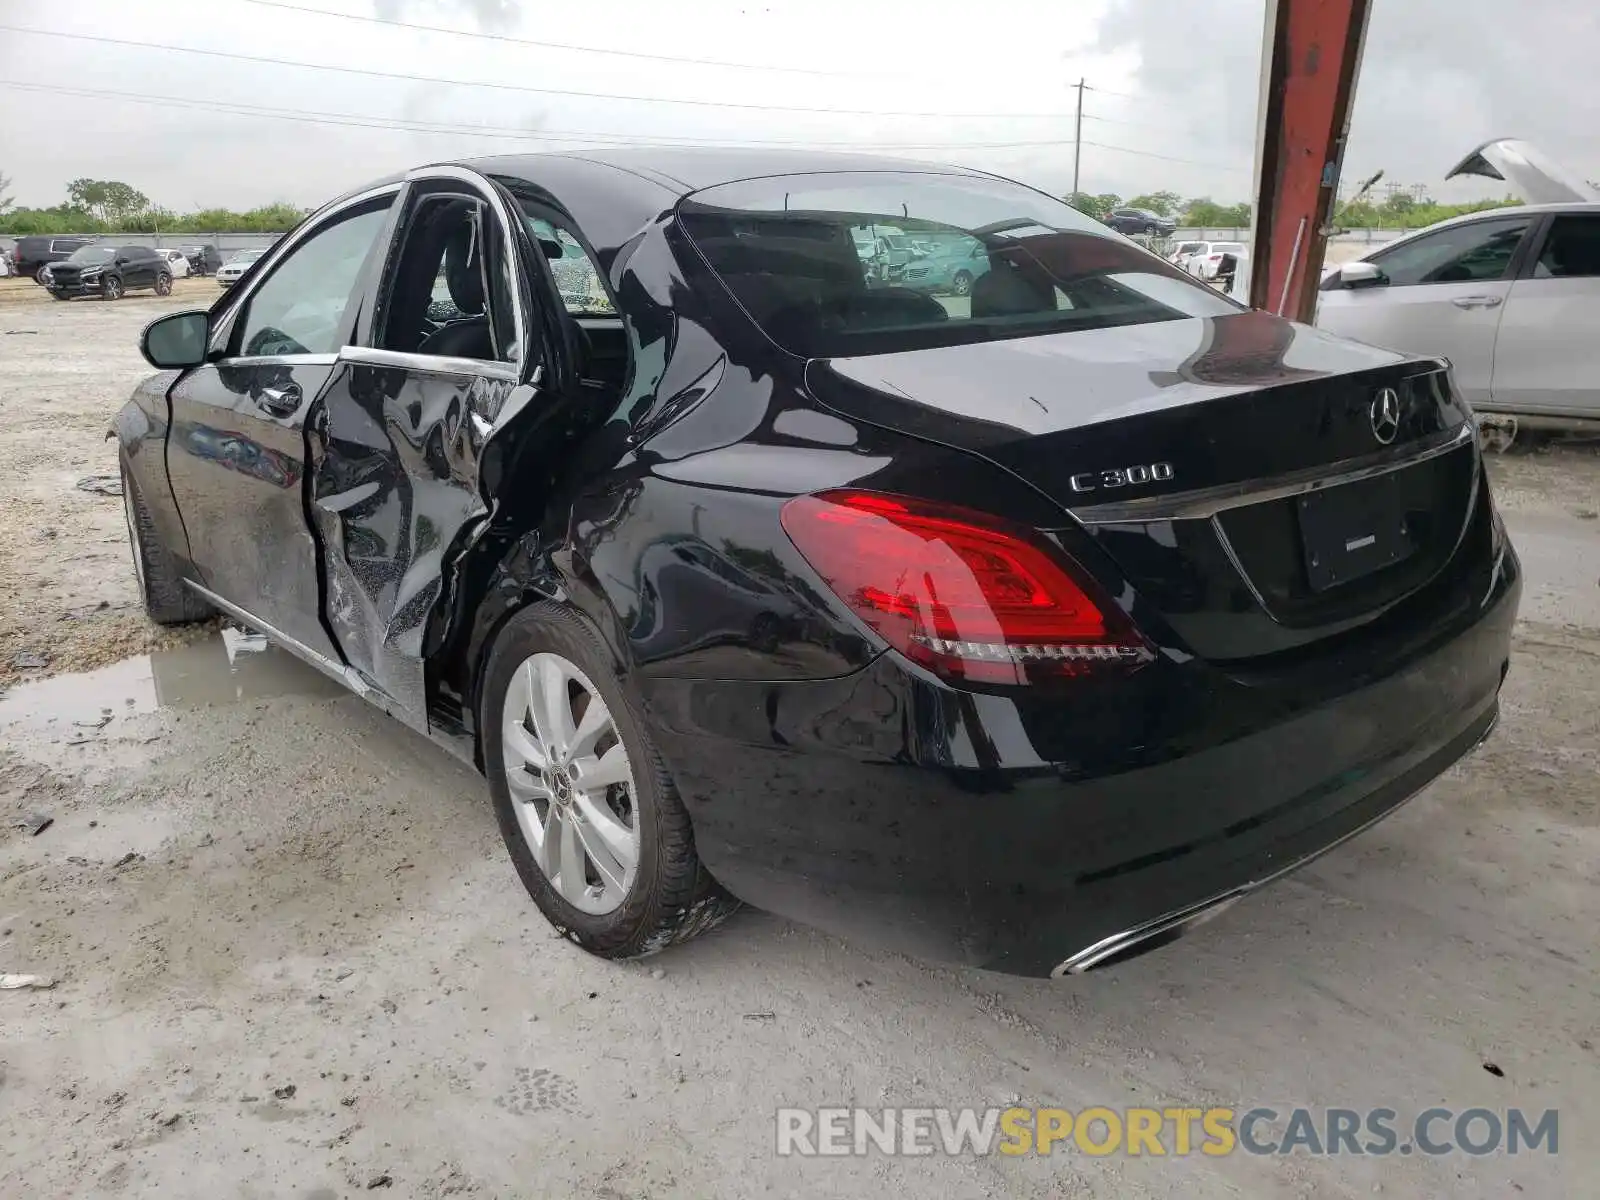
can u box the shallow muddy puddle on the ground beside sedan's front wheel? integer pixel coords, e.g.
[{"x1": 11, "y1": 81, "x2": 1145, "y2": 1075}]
[{"x1": 0, "y1": 629, "x2": 344, "y2": 739}]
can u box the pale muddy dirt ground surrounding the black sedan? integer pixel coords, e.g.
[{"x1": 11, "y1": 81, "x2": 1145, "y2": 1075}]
[{"x1": 0, "y1": 280, "x2": 1600, "y2": 1200}]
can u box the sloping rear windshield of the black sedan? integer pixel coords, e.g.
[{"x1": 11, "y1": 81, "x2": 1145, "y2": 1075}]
[{"x1": 678, "y1": 171, "x2": 1238, "y2": 358}]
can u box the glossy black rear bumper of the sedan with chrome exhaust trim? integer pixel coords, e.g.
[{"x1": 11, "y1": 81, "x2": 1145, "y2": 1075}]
[{"x1": 645, "y1": 546, "x2": 1520, "y2": 974}]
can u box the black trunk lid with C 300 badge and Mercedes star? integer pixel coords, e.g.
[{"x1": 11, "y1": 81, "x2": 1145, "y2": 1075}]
[{"x1": 806, "y1": 312, "x2": 1478, "y2": 659}]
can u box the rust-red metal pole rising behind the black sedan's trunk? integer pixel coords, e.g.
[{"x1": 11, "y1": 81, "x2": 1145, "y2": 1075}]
[{"x1": 1250, "y1": 0, "x2": 1371, "y2": 322}]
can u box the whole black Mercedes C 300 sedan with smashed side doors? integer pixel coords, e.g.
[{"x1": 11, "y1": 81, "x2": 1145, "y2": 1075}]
[{"x1": 114, "y1": 149, "x2": 1520, "y2": 974}]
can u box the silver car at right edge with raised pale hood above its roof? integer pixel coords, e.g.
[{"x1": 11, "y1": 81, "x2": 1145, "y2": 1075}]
[{"x1": 1317, "y1": 141, "x2": 1600, "y2": 419}]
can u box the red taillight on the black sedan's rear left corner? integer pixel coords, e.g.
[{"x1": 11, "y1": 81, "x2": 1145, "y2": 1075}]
[{"x1": 782, "y1": 491, "x2": 1150, "y2": 683}]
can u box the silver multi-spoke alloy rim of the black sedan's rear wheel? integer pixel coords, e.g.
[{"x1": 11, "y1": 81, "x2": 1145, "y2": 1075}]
[{"x1": 501, "y1": 651, "x2": 640, "y2": 915}]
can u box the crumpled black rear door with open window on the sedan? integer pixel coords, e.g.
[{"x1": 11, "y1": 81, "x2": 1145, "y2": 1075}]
[{"x1": 310, "y1": 166, "x2": 539, "y2": 733}]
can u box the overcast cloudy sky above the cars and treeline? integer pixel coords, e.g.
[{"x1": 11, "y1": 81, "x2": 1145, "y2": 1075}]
[{"x1": 0, "y1": 0, "x2": 1600, "y2": 210}]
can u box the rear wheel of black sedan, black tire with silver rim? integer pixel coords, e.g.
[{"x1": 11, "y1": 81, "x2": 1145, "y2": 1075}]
[{"x1": 480, "y1": 602, "x2": 739, "y2": 958}]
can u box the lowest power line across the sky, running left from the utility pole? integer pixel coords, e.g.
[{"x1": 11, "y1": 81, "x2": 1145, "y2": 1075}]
[{"x1": 0, "y1": 80, "x2": 1094, "y2": 150}]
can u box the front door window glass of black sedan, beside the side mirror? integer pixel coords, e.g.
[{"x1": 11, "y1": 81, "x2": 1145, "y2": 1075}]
[{"x1": 234, "y1": 202, "x2": 389, "y2": 357}]
